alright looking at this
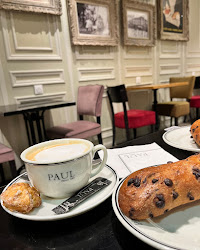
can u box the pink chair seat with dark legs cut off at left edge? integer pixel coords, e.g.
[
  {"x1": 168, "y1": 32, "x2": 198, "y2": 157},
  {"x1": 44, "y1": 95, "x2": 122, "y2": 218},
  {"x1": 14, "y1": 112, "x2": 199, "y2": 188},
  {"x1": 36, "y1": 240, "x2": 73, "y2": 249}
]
[{"x1": 0, "y1": 143, "x2": 17, "y2": 182}]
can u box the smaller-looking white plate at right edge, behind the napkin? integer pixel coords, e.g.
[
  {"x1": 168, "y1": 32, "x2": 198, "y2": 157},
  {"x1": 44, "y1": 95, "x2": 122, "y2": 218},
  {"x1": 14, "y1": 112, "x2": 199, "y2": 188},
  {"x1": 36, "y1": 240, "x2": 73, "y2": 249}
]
[{"x1": 163, "y1": 126, "x2": 200, "y2": 152}]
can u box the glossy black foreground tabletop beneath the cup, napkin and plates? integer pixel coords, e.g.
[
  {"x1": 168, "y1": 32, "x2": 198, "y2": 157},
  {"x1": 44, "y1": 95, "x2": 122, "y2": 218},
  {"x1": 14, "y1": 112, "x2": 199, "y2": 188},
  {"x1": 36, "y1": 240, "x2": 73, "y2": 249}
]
[{"x1": 0, "y1": 131, "x2": 193, "y2": 250}]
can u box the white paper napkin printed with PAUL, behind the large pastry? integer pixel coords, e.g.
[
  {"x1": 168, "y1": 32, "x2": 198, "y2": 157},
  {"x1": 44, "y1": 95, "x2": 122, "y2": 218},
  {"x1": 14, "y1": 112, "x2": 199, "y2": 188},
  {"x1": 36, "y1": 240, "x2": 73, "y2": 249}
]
[{"x1": 99, "y1": 142, "x2": 178, "y2": 178}]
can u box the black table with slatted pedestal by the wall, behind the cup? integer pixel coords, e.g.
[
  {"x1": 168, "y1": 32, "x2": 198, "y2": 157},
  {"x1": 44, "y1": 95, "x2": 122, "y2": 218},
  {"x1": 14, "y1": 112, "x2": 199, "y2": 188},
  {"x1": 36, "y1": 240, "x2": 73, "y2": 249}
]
[{"x1": 0, "y1": 101, "x2": 76, "y2": 146}]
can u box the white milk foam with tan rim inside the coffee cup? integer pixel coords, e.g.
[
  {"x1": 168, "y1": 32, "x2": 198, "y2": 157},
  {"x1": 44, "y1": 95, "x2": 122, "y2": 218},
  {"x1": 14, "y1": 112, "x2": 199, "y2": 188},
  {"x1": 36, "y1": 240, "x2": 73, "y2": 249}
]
[{"x1": 25, "y1": 140, "x2": 90, "y2": 163}]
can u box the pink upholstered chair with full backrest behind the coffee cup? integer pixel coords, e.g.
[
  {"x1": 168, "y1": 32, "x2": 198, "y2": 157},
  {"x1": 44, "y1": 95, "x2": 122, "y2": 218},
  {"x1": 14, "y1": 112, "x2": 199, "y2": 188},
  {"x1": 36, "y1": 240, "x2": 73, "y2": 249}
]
[{"x1": 46, "y1": 84, "x2": 104, "y2": 144}]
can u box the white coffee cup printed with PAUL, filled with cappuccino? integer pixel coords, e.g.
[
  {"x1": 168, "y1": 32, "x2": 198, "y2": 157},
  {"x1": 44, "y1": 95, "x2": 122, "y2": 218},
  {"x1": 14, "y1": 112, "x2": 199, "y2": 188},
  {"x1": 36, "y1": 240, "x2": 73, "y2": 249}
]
[{"x1": 21, "y1": 139, "x2": 107, "y2": 198}]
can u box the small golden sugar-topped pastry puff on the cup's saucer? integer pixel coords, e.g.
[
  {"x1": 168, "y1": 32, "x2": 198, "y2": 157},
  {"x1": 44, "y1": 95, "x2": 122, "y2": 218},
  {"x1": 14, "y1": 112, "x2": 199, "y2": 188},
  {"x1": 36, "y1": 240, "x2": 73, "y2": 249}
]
[{"x1": 1, "y1": 182, "x2": 41, "y2": 214}]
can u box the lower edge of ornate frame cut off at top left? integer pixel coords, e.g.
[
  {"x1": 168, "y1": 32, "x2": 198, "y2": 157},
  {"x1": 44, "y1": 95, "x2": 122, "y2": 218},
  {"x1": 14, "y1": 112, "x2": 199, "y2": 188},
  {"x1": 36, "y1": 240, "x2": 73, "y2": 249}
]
[{"x1": 0, "y1": 0, "x2": 62, "y2": 15}]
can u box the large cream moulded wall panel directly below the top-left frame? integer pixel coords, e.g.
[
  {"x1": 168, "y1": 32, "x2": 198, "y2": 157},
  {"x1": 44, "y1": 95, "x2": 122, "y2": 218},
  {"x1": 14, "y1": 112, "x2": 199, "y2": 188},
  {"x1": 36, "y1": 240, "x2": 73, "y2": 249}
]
[{"x1": 1, "y1": 12, "x2": 61, "y2": 61}]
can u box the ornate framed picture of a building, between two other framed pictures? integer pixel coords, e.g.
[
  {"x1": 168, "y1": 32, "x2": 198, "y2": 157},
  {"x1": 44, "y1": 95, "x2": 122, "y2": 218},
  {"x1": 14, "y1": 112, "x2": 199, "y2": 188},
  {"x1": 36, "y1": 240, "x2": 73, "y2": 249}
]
[{"x1": 122, "y1": 0, "x2": 156, "y2": 46}]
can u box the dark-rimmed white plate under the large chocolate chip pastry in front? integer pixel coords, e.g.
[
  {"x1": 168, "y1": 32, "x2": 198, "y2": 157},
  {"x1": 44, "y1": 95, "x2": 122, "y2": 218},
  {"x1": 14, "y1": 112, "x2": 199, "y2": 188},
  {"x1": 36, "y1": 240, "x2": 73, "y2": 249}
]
[{"x1": 112, "y1": 178, "x2": 200, "y2": 250}]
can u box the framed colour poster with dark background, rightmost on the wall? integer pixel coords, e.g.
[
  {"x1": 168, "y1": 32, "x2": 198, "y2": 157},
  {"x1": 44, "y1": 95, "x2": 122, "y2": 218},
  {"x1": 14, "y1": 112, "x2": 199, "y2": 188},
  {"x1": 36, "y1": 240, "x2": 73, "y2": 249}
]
[{"x1": 157, "y1": 0, "x2": 189, "y2": 41}]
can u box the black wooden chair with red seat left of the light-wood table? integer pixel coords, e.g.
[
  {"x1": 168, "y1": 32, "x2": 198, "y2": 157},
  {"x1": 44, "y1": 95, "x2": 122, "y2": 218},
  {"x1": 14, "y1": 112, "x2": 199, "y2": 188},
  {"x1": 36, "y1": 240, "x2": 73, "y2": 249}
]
[{"x1": 107, "y1": 84, "x2": 156, "y2": 146}]
